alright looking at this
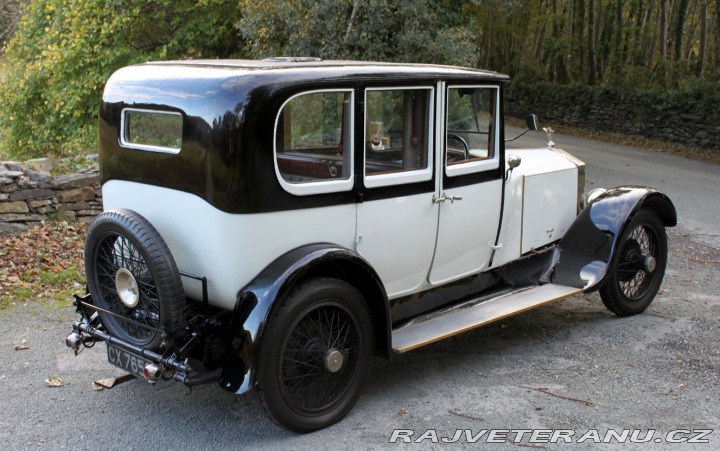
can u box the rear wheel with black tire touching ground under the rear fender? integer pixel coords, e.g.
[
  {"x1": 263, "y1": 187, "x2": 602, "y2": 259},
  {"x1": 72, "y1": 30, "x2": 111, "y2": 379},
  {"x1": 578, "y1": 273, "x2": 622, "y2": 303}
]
[{"x1": 257, "y1": 278, "x2": 373, "y2": 432}]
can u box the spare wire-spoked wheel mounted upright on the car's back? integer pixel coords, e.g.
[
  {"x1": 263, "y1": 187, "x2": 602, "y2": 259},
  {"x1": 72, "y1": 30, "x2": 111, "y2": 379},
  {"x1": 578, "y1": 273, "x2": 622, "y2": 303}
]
[{"x1": 85, "y1": 210, "x2": 186, "y2": 350}]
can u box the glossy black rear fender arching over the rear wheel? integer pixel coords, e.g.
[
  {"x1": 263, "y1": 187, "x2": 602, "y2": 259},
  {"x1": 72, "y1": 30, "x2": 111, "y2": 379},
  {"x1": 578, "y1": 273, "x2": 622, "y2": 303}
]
[{"x1": 220, "y1": 243, "x2": 390, "y2": 394}]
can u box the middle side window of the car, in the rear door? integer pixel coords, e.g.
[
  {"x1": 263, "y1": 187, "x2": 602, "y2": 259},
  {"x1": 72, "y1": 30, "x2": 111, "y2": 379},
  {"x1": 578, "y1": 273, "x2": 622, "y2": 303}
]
[{"x1": 364, "y1": 88, "x2": 433, "y2": 187}]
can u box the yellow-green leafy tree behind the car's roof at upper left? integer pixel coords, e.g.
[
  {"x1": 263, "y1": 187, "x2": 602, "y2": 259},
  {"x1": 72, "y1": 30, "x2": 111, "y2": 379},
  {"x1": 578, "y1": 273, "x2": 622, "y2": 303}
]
[{"x1": 0, "y1": 0, "x2": 240, "y2": 157}]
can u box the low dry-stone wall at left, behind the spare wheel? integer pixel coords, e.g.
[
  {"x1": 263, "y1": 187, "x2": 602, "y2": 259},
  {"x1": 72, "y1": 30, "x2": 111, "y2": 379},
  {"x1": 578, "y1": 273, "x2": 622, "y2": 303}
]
[{"x1": 0, "y1": 159, "x2": 102, "y2": 235}]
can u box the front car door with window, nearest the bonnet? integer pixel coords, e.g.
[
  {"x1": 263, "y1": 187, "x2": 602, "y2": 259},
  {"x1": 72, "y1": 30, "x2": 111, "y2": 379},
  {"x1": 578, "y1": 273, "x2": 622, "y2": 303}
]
[{"x1": 428, "y1": 84, "x2": 503, "y2": 285}]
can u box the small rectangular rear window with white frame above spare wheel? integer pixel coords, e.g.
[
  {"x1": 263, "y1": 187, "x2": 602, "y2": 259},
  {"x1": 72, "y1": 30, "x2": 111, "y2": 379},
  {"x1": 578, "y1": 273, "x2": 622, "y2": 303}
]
[{"x1": 120, "y1": 108, "x2": 183, "y2": 153}]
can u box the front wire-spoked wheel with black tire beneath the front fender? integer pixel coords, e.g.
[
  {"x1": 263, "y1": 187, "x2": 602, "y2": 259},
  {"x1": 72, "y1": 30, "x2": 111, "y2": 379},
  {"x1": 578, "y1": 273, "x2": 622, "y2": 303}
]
[{"x1": 600, "y1": 209, "x2": 667, "y2": 316}]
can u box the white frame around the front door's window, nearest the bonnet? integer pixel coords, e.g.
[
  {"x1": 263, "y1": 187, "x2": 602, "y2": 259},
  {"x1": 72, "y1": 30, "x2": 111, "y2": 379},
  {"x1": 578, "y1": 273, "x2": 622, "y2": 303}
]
[{"x1": 442, "y1": 84, "x2": 500, "y2": 177}]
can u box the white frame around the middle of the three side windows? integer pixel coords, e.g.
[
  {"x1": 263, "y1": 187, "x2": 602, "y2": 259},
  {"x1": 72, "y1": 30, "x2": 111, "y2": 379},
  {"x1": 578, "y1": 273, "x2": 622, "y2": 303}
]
[{"x1": 362, "y1": 84, "x2": 436, "y2": 188}]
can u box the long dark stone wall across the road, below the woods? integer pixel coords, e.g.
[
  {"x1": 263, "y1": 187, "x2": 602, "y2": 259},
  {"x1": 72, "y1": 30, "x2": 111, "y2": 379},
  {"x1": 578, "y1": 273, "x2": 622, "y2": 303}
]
[{"x1": 505, "y1": 82, "x2": 720, "y2": 150}]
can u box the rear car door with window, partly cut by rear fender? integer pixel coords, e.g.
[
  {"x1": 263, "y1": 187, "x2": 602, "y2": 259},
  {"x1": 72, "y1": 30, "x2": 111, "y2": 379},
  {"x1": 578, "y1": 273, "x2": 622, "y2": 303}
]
[{"x1": 355, "y1": 85, "x2": 439, "y2": 298}]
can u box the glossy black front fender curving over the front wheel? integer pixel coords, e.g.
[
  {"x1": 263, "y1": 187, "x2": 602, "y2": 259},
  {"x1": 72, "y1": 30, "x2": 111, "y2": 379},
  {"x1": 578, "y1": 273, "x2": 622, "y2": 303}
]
[{"x1": 553, "y1": 186, "x2": 677, "y2": 293}]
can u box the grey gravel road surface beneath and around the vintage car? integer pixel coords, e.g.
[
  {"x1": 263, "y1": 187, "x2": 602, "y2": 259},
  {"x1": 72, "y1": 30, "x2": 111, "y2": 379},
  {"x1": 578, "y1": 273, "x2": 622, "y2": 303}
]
[{"x1": 0, "y1": 131, "x2": 720, "y2": 450}]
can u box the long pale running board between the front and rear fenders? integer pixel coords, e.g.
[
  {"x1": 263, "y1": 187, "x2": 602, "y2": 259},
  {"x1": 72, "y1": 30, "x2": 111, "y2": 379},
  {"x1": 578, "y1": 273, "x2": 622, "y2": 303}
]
[{"x1": 392, "y1": 283, "x2": 582, "y2": 353}]
